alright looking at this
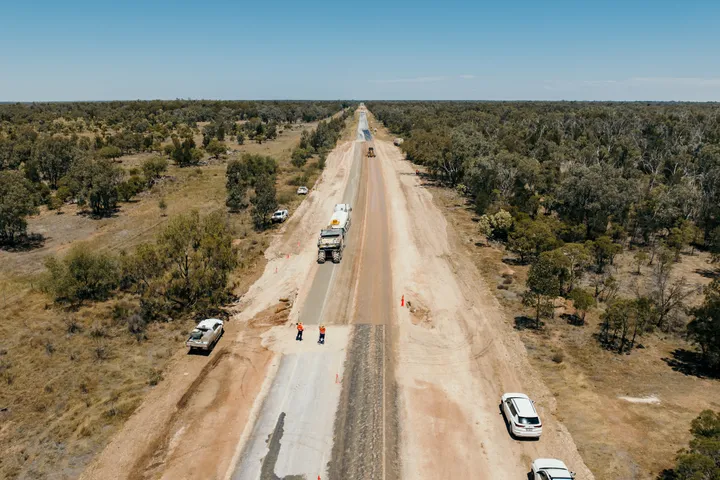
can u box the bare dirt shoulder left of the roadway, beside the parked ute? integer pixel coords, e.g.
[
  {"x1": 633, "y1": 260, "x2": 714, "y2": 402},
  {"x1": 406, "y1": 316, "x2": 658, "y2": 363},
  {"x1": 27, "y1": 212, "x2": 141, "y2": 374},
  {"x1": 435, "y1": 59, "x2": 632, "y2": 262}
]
[{"x1": 82, "y1": 139, "x2": 360, "y2": 480}]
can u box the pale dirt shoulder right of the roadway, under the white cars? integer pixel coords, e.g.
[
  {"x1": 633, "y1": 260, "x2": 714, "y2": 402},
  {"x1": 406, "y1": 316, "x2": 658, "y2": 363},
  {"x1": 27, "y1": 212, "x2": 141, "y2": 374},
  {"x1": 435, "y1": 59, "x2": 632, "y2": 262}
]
[{"x1": 375, "y1": 133, "x2": 594, "y2": 479}]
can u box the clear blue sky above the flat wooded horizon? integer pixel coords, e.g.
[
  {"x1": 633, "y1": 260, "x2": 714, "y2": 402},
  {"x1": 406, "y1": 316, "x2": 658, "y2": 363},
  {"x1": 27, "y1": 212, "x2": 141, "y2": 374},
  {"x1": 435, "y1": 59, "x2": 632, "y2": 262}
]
[{"x1": 0, "y1": 0, "x2": 720, "y2": 101}]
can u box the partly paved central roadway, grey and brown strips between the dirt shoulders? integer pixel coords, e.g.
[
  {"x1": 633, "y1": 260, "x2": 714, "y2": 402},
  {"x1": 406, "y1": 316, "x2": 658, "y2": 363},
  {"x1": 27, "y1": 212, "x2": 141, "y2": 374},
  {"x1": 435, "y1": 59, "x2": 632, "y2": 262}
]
[{"x1": 232, "y1": 109, "x2": 399, "y2": 480}]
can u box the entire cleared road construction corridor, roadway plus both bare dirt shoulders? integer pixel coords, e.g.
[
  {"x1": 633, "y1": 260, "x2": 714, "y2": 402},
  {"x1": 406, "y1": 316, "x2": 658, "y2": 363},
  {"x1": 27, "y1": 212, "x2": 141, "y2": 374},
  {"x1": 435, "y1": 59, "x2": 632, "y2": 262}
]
[{"x1": 83, "y1": 107, "x2": 593, "y2": 480}]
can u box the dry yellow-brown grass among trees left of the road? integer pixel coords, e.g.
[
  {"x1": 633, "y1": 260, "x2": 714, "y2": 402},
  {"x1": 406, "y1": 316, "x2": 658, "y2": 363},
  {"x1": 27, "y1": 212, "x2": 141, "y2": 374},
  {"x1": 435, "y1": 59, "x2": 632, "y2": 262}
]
[{"x1": 0, "y1": 117, "x2": 344, "y2": 478}]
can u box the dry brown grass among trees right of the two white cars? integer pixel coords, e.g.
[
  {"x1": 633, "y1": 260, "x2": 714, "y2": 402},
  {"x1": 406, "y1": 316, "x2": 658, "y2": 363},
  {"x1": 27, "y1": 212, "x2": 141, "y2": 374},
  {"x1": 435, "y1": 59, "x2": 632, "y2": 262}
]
[{"x1": 433, "y1": 188, "x2": 720, "y2": 480}]
